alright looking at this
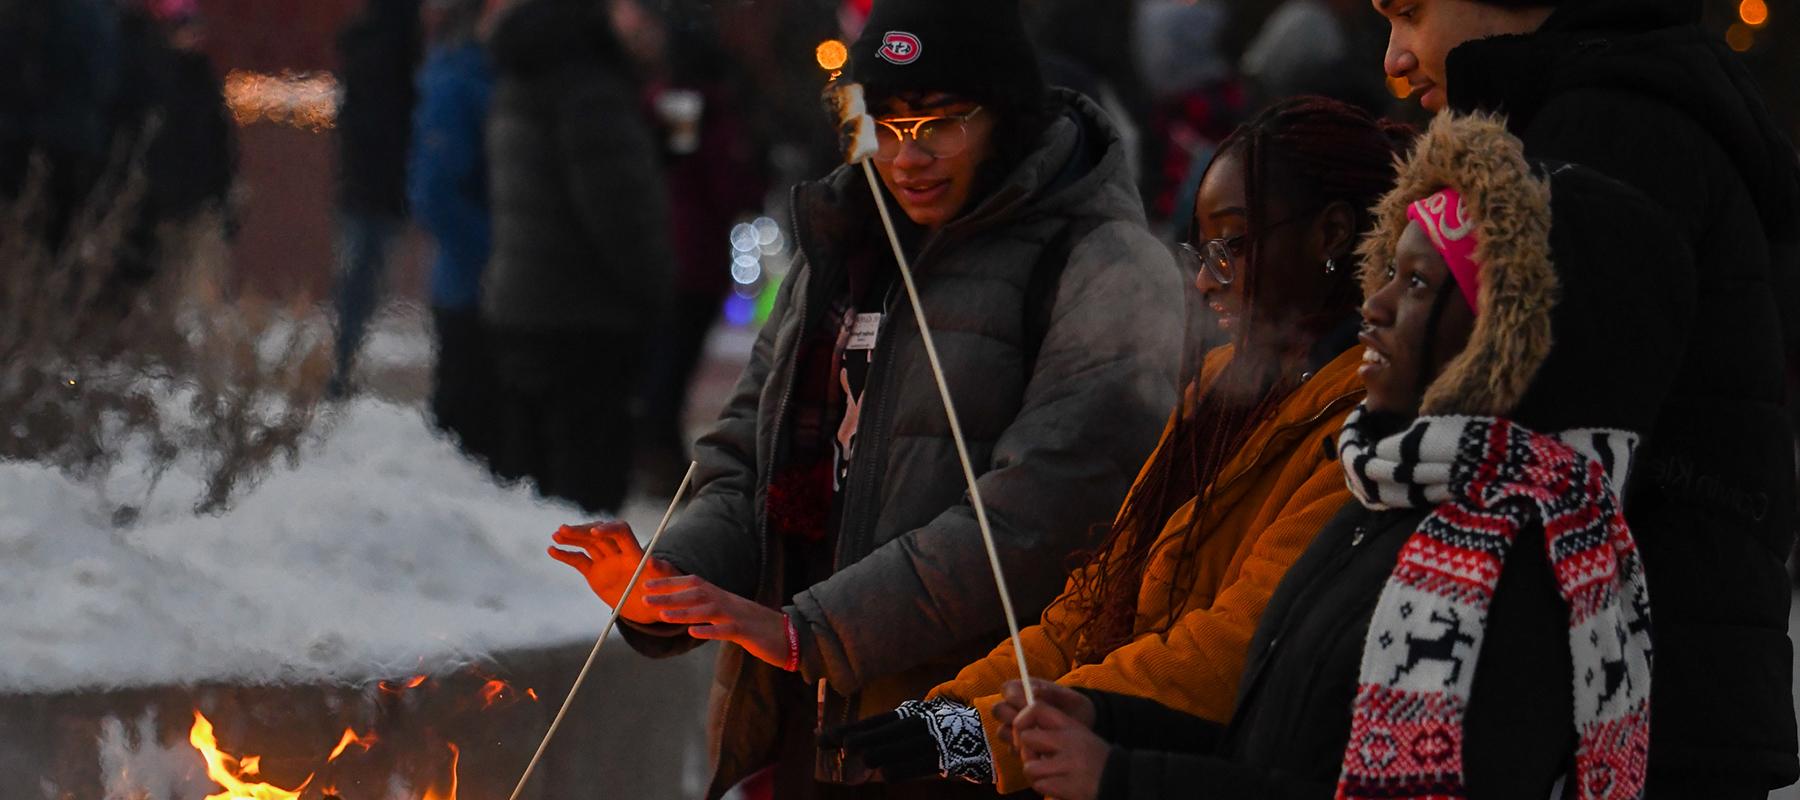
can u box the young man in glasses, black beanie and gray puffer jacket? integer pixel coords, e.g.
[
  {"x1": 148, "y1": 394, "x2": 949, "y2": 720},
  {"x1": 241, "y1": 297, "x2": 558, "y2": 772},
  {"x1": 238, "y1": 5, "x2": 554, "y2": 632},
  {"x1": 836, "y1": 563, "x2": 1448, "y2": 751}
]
[{"x1": 556, "y1": 0, "x2": 1184, "y2": 798}]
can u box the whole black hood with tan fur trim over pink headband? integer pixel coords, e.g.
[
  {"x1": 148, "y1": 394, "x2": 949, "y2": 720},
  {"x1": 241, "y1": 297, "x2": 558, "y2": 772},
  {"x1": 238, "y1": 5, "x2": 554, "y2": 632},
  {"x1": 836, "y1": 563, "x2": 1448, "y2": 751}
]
[{"x1": 1357, "y1": 114, "x2": 1694, "y2": 432}]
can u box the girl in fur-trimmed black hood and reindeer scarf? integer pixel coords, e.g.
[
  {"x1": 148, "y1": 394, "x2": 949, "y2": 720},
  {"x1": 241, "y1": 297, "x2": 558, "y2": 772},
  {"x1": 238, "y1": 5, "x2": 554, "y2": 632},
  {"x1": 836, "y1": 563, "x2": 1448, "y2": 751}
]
[{"x1": 1006, "y1": 115, "x2": 1694, "y2": 800}]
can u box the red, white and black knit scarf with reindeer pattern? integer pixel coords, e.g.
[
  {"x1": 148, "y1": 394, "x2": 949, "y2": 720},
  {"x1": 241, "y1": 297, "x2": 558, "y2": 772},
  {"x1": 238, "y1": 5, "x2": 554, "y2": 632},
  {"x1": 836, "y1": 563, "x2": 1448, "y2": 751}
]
[{"x1": 1337, "y1": 407, "x2": 1651, "y2": 800}]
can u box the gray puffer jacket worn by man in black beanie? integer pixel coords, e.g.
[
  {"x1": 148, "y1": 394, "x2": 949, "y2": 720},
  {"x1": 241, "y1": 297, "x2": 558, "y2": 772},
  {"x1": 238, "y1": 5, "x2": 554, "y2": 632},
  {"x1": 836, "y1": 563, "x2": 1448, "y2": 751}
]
[{"x1": 626, "y1": 92, "x2": 1183, "y2": 796}]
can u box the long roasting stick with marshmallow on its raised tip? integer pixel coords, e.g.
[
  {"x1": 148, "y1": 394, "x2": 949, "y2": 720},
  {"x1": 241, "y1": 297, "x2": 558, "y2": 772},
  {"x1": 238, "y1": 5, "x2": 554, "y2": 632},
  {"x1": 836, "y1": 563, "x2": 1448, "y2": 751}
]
[{"x1": 824, "y1": 79, "x2": 1037, "y2": 706}]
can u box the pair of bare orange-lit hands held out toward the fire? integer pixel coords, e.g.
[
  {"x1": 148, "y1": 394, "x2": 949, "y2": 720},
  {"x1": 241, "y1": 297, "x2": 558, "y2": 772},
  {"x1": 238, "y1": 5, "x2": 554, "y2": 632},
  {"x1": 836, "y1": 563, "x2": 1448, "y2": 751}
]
[{"x1": 549, "y1": 523, "x2": 790, "y2": 667}]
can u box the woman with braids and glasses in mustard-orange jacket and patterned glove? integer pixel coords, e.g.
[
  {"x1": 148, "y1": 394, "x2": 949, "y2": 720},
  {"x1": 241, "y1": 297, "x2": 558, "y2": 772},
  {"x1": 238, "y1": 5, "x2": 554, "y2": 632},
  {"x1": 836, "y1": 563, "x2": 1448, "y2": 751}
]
[{"x1": 828, "y1": 97, "x2": 1397, "y2": 793}]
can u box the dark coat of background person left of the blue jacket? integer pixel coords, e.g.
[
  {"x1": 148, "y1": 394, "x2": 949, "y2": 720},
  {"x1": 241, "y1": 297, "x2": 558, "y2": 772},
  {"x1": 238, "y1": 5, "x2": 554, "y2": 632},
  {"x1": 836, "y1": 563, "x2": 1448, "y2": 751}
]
[{"x1": 337, "y1": 0, "x2": 423, "y2": 218}]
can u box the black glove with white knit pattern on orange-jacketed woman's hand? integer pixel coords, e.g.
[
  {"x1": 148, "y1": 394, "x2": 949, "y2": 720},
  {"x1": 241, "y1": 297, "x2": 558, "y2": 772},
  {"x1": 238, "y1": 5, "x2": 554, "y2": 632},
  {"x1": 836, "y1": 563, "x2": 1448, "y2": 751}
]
[{"x1": 821, "y1": 697, "x2": 994, "y2": 784}]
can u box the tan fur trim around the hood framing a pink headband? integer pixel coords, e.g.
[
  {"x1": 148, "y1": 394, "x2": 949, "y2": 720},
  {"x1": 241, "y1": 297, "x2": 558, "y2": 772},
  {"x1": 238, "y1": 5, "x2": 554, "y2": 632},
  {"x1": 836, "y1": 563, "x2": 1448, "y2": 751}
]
[{"x1": 1357, "y1": 114, "x2": 1557, "y2": 416}]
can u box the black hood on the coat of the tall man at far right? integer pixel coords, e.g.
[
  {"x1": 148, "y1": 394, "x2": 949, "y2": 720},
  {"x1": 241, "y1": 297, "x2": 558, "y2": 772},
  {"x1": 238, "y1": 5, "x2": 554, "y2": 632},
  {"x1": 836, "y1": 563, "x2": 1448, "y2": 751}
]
[{"x1": 1445, "y1": 7, "x2": 1800, "y2": 243}]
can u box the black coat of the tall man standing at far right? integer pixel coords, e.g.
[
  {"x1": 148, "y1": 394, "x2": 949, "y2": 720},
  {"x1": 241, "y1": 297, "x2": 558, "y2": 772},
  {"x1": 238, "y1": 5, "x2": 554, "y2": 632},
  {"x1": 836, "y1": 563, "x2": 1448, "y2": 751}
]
[{"x1": 1445, "y1": 0, "x2": 1800, "y2": 796}]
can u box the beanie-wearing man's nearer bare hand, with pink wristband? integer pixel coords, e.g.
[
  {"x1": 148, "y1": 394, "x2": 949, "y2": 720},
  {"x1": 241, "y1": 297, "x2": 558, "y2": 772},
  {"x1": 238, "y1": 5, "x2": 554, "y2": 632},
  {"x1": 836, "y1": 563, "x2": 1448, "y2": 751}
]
[{"x1": 644, "y1": 575, "x2": 788, "y2": 668}]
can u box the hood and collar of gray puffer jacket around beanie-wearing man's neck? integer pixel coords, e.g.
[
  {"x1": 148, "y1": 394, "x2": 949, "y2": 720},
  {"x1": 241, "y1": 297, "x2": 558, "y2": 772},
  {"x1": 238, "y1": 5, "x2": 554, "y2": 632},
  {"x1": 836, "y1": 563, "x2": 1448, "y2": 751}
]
[{"x1": 794, "y1": 88, "x2": 1143, "y2": 270}]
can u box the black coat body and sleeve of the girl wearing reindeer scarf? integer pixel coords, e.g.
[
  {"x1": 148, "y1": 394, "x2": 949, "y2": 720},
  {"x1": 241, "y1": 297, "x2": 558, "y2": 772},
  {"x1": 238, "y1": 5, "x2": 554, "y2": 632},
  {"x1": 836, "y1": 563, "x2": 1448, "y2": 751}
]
[{"x1": 1085, "y1": 503, "x2": 1575, "y2": 800}]
